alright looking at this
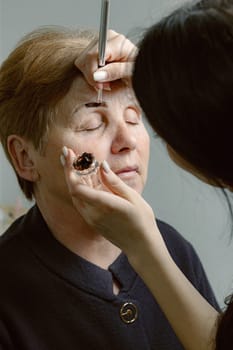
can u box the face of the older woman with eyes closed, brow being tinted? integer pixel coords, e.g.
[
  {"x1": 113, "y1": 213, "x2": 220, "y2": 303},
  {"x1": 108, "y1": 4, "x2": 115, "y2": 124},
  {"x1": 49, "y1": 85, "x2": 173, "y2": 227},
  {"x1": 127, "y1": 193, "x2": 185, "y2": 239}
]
[{"x1": 34, "y1": 77, "x2": 149, "y2": 202}]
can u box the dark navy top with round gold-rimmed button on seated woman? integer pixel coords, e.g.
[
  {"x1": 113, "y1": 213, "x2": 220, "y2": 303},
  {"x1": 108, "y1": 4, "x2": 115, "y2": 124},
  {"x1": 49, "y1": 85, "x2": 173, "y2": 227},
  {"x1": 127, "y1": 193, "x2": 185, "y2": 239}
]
[{"x1": 0, "y1": 206, "x2": 218, "y2": 350}]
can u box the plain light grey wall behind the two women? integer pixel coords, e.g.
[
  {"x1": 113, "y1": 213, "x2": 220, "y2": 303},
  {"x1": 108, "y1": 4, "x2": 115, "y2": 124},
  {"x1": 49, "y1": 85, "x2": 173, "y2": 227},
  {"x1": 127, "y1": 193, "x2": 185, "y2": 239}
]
[{"x1": 0, "y1": 0, "x2": 233, "y2": 305}]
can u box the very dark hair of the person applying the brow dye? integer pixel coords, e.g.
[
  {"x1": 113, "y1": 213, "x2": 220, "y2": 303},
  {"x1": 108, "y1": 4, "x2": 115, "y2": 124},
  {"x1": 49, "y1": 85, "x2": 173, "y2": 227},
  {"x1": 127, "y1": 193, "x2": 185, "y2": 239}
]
[{"x1": 133, "y1": 0, "x2": 233, "y2": 349}]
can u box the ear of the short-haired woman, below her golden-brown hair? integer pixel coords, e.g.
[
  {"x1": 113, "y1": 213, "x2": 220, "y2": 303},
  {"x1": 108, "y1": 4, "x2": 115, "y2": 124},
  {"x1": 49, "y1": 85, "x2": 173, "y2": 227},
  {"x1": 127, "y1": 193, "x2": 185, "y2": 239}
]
[{"x1": 7, "y1": 135, "x2": 39, "y2": 182}]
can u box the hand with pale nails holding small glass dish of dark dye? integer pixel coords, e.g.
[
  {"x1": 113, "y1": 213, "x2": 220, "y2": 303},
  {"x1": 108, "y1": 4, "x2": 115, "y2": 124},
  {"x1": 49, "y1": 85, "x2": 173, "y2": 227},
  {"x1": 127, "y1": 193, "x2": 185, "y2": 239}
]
[{"x1": 60, "y1": 149, "x2": 160, "y2": 259}]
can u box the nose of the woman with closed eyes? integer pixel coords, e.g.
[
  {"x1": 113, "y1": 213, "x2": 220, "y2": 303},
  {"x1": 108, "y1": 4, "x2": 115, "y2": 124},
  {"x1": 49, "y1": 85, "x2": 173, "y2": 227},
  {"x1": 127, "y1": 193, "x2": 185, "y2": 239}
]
[{"x1": 112, "y1": 122, "x2": 137, "y2": 153}]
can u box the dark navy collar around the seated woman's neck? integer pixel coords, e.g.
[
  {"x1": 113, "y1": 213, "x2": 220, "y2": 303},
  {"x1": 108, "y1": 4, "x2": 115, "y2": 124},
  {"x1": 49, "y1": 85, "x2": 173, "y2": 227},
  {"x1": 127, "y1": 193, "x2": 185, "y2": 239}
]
[{"x1": 21, "y1": 206, "x2": 137, "y2": 300}]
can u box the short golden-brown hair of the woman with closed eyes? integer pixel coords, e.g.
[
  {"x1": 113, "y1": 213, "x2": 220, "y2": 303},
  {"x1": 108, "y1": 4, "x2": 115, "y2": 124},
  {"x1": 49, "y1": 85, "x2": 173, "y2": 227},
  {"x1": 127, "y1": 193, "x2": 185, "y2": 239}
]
[{"x1": 0, "y1": 26, "x2": 96, "y2": 199}]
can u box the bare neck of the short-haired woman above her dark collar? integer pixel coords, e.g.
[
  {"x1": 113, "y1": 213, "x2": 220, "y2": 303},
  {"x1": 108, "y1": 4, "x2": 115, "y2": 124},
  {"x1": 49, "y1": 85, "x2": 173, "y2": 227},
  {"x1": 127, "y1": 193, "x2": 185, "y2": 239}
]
[{"x1": 37, "y1": 198, "x2": 121, "y2": 269}]
